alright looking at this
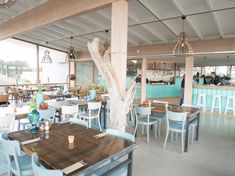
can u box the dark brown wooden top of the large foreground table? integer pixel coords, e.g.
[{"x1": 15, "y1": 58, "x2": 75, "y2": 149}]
[{"x1": 9, "y1": 123, "x2": 136, "y2": 175}]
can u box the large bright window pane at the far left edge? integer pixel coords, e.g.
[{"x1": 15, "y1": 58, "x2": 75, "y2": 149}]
[{"x1": 0, "y1": 39, "x2": 37, "y2": 85}]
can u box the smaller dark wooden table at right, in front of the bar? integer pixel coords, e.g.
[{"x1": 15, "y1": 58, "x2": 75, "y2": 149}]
[{"x1": 140, "y1": 103, "x2": 201, "y2": 152}]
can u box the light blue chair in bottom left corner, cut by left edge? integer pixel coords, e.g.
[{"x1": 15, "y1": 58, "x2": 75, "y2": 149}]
[{"x1": 1, "y1": 137, "x2": 33, "y2": 176}]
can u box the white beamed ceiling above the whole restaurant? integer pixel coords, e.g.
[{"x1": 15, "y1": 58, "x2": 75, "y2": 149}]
[{"x1": 0, "y1": 0, "x2": 235, "y2": 55}]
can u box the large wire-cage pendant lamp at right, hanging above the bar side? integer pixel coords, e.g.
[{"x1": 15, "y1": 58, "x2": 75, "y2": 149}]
[{"x1": 173, "y1": 16, "x2": 193, "y2": 56}]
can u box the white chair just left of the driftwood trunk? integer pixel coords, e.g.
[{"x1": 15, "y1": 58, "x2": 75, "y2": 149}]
[{"x1": 80, "y1": 102, "x2": 102, "y2": 131}]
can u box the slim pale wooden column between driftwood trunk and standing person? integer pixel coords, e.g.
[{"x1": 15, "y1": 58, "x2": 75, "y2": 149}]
[{"x1": 140, "y1": 58, "x2": 147, "y2": 104}]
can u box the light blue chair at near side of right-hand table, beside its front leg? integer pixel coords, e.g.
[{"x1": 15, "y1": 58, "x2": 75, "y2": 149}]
[{"x1": 163, "y1": 110, "x2": 187, "y2": 152}]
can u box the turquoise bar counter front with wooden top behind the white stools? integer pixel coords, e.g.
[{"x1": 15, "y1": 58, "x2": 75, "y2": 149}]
[{"x1": 192, "y1": 85, "x2": 235, "y2": 112}]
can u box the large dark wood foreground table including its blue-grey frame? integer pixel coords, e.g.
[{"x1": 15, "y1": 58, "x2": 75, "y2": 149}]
[{"x1": 9, "y1": 123, "x2": 137, "y2": 176}]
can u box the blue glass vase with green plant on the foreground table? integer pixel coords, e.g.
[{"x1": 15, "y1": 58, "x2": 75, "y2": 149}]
[{"x1": 28, "y1": 98, "x2": 40, "y2": 133}]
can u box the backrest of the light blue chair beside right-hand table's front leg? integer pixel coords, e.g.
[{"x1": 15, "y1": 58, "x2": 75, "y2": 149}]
[{"x1": 166, "y1": 110, "x2": 187, "y2": 127}]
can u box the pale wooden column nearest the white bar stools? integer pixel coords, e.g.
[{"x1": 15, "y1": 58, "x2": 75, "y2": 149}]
[{"x1": 184, "y1": 56, "x2": 194, "y2": 105}]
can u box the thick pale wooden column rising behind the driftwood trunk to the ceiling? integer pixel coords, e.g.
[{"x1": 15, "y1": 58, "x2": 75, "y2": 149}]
[{"x1": 111, "y1": 0, "x2": 128, "y2": 95}]
